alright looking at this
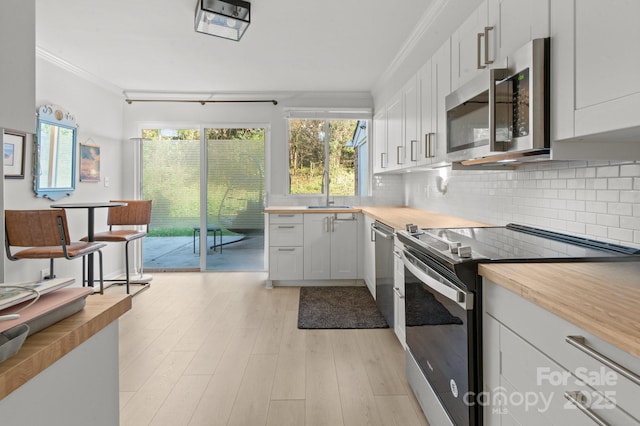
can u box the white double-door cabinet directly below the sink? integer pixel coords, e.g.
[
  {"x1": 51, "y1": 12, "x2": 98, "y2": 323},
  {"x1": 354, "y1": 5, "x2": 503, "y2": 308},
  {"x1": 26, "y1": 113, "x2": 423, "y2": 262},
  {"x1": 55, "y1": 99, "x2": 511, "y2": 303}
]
[{"x1": 303, "y1": 213, "x2": 360, "y2": 280}]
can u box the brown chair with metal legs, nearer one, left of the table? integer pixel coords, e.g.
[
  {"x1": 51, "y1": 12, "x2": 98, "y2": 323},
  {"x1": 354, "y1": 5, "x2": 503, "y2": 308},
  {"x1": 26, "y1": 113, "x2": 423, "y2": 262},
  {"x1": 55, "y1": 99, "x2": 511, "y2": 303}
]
[{"x1": 4, "y1": 209, "x2": 106, "y2": 294}]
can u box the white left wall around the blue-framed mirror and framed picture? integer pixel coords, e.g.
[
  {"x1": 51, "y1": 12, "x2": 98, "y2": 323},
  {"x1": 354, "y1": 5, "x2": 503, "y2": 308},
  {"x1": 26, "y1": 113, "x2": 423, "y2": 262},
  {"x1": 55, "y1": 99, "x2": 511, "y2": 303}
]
[{"x1": 3, "y1": 58, "x2": 129, "y2": 285}]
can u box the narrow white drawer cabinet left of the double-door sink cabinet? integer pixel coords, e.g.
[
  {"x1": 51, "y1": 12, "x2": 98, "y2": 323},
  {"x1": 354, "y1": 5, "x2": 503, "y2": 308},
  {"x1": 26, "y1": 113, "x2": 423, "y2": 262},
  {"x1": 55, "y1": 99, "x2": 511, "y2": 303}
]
[{"x1": 268, "y1": 213, "x2": 304, "y2": 281}]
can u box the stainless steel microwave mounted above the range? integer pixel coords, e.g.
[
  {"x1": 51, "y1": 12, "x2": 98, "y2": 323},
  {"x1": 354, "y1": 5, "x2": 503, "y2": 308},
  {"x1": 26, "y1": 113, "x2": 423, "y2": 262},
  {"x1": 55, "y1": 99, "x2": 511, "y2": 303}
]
[{"x1": 445, "y1": 38, "x2": 550, "y2": 165}]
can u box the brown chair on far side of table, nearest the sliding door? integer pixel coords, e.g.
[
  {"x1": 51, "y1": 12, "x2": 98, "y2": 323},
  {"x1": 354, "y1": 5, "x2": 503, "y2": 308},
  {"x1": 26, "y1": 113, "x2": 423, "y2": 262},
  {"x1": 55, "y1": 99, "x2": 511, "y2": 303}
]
[{"x1": 83, "y1": 200, "x2": 151, "y2": 294}]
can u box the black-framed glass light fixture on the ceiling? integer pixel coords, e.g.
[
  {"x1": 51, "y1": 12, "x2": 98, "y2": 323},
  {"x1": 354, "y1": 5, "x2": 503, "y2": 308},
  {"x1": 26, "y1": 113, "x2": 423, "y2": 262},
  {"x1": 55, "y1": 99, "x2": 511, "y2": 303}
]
[{"x1": 195, "y1": 0, "x2": 251, "y2": 41}]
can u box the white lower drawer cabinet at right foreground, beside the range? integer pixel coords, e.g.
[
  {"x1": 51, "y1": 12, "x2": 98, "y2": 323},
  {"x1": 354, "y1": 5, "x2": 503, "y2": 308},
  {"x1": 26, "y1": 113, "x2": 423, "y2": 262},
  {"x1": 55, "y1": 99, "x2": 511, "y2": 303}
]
[{"x1": 480, "y1": 280, "x2": 640, "y2": 426}]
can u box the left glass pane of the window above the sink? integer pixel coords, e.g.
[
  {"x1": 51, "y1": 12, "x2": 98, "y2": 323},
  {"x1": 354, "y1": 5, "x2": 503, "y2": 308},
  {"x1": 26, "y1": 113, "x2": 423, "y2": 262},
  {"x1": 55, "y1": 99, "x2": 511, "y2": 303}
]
[{"x1": 289, "y1": 120, "x2": 325, "y2": 194}]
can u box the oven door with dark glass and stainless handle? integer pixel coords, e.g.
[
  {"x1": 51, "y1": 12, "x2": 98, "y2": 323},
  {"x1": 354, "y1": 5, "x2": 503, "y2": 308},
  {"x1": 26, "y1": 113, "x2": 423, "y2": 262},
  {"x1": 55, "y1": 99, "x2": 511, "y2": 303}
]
[{"x1": 402, "y1": 249, "x2": 481, "y2": 425}]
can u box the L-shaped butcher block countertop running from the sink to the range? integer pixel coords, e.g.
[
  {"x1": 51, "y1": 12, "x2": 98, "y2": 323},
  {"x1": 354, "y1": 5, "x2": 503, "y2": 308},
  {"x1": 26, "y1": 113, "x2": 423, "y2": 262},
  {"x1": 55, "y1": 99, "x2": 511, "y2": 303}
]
[{"x1": 264, "y1": 206, "x2": 491, "y2": 230}]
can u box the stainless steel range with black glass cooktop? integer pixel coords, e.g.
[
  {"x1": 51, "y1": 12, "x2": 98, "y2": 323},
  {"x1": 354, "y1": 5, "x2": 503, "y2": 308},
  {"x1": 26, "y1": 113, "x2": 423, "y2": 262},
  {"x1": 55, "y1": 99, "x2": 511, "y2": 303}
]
[{"x1": 396, "y1": 224, "x2": 640, "y2": 425}]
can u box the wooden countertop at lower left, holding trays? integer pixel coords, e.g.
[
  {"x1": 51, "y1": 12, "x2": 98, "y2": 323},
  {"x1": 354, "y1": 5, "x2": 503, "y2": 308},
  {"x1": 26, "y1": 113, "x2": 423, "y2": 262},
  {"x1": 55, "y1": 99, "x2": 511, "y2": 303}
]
[{"x1": 0, "y1": 295, "x2": 131, "y2": 399}]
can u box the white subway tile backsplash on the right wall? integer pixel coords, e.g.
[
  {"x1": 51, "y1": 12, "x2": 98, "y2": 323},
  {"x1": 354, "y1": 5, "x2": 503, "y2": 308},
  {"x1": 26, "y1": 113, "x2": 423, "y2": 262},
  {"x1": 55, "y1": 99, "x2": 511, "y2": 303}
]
[{"x1": 396, "y1": 161, "x2": 640, "y2": 247}]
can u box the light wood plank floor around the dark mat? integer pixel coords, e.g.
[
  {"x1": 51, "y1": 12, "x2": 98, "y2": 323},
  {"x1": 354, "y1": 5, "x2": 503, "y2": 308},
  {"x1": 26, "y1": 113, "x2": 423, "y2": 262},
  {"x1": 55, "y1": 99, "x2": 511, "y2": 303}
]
[{"x1": 120, "y1": 272, "x2": 427, "y2": 426}]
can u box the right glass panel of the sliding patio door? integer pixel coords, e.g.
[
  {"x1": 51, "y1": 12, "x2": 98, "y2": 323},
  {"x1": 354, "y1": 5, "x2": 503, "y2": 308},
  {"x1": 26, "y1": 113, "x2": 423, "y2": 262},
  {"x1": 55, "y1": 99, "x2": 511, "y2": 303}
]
[{"x1": 201, "y1": 127, "x2": 266, "y2": 271}]
